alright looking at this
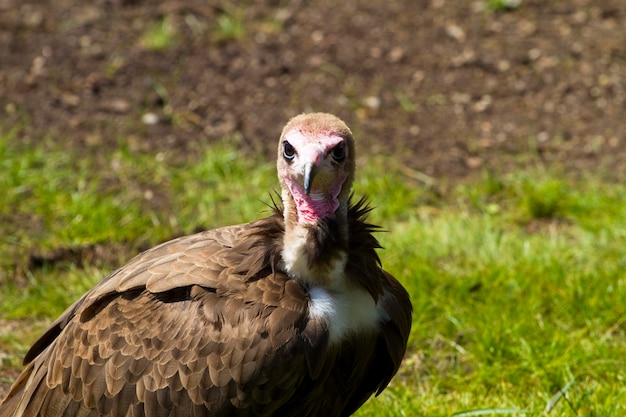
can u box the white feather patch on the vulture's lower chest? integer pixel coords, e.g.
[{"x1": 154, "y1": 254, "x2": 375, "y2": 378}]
[{"x1": 309, "y1": 287, "x2": 381, "y2": 343}]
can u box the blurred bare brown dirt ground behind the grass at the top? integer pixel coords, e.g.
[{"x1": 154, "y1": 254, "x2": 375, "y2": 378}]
[{"x1": 0, "y1": 0, "x2": 626, "y2": 396}]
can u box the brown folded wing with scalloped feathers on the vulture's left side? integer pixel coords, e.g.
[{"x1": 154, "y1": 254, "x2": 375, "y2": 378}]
[{"x1": 3, "y1": 219, "x2": 316, "y2": 416}]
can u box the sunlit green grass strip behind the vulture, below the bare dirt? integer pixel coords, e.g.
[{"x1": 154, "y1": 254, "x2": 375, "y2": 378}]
[{"x1": 0, "y1": 132, "x2": 626, "y2": 417}]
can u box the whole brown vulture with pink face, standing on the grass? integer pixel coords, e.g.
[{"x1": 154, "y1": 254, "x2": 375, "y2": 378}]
[{"x1": 0, "y1": 113, "x2": 412, "y2": 417}]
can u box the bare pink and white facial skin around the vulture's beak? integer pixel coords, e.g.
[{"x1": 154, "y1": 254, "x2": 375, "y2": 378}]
[{"x1": 281, "y1": 130, "x2": 347, "y2": 223}]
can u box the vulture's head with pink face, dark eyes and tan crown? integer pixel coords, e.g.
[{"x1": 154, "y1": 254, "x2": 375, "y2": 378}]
[{"x1": 277, "y1": 113, "x2": 355, "y2": 224}]
